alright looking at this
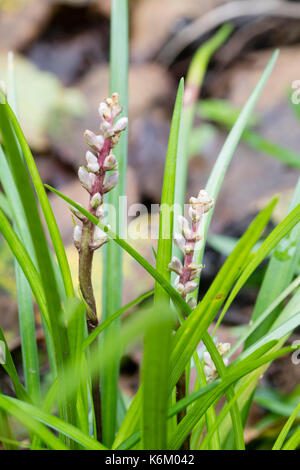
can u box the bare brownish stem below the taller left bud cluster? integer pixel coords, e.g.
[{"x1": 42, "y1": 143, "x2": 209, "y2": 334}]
[{"x1": 79, "y1": 221, "x2": 102, "y2": 442}]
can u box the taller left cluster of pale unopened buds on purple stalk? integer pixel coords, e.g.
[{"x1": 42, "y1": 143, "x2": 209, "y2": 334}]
[{"x1": 71, "y1": 93, "x2": 128, "y2": 250}]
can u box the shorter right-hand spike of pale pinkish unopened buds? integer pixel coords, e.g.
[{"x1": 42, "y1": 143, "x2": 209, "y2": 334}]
[{"x1": 169, "y1": 189, "x2": 214, "y2": 308}]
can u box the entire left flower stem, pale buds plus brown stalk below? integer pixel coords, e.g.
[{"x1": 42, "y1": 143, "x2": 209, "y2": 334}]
[{"x1": 71, "y1": 93, "x2": 128, "y2": 442}]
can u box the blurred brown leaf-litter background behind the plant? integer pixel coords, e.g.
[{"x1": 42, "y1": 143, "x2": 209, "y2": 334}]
[{"x1": 0, "y1": 0, "x2": 300, "y2": 446}]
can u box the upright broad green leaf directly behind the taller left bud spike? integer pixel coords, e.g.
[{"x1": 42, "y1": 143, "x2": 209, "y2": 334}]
[{"x1": 100, "y1": 0, "x2": 128, "y2": 446}]
